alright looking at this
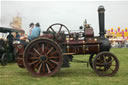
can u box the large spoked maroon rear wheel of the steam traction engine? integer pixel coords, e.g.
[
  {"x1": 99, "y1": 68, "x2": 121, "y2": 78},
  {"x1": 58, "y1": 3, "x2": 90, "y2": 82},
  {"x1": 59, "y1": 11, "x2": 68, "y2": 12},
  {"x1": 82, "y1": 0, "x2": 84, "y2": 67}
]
[{"x1": 24, "y1": 39, "x2": 62, "y2": 77}]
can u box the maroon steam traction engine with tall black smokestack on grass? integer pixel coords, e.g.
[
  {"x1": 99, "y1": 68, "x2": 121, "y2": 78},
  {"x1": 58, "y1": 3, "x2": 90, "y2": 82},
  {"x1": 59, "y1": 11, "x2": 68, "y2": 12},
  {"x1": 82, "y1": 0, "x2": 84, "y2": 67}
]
[{"x1": 17, "y1": 6, "x2": 119, "y2": 77}]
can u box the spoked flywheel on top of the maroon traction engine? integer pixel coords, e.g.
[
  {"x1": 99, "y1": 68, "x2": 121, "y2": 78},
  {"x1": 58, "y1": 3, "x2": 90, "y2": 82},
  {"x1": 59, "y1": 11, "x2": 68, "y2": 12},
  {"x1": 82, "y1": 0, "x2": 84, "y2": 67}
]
[{"x1": 47, "y1": 23, "x2": 70, "y2": 35}]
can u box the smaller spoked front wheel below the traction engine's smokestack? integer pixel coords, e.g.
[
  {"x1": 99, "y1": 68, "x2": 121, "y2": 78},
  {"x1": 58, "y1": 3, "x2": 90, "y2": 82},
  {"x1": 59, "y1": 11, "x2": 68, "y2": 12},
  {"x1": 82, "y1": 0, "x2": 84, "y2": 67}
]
[{"x1": 93, "y1": 52, "x2": 119, "y2": 76}]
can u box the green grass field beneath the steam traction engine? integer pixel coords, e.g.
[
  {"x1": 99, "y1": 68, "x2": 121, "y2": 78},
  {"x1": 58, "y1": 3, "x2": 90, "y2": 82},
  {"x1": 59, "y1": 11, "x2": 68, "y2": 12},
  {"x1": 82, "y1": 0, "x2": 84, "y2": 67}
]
[{"x1": 0, "y1": 48, "x2": 128, "y2": 85}]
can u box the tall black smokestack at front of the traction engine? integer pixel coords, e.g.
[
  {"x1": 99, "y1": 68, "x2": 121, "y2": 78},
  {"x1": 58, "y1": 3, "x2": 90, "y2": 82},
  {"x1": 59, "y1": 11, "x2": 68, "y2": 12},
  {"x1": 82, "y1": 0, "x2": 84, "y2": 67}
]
[{"x1": 98, "y1": 5, "x2": 105, "y2": 38}]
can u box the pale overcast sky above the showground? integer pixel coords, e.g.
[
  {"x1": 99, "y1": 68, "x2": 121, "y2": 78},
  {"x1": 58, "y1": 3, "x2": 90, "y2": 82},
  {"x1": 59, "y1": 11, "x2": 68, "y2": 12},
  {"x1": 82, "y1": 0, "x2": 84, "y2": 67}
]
[{"x1": 0, "y1": 1, "x2": 128, "y2": 35}]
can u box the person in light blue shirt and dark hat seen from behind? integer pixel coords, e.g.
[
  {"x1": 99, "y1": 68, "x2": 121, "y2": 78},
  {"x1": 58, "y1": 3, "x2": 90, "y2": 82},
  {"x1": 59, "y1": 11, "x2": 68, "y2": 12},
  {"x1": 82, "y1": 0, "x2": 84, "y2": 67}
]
[{"x1": 28, "y1": 23, "x2": 41, "y2": 40}]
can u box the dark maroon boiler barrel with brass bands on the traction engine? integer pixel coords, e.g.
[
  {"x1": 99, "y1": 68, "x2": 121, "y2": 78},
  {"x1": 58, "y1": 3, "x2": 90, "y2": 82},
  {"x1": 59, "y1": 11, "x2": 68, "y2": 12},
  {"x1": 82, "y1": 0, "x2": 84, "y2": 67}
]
[{"x1": 66, "y1": 38, "x2": 100, "y2": 55}]
